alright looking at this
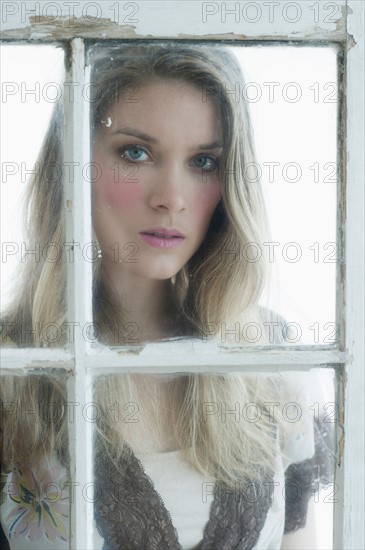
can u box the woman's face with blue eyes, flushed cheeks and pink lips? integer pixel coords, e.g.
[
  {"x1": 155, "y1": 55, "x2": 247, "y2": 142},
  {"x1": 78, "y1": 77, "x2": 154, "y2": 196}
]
[{"x1": 93, "y1": 80, "x2": 222, "y2": 279}]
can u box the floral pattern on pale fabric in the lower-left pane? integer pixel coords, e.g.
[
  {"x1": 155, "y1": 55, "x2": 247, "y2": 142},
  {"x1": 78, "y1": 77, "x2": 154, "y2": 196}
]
[{"x1": 5, "y1": 461, "x2": 70, "y2": 542}]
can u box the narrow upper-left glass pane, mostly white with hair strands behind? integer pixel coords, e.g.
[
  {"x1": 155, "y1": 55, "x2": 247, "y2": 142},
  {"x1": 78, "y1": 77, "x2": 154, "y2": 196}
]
[{"x1": 1, "y1": 45, "x2": 65, "y2": 347}]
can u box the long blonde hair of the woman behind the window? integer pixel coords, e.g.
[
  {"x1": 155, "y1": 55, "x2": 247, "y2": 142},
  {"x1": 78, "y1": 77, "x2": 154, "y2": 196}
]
[{"x1": 4, "y1": 44, "x2": 288, "y2": 485}]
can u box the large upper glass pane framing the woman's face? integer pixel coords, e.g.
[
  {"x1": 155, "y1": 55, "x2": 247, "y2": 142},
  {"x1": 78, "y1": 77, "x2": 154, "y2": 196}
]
[{"x1": 89, "y1": 42, "x2": 341, "y2": 352}]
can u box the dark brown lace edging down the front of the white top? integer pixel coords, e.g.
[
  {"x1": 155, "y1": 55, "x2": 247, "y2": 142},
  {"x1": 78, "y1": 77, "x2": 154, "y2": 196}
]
[{"x1": 95, "y1": 449, "x2": 273, "y2": 550}]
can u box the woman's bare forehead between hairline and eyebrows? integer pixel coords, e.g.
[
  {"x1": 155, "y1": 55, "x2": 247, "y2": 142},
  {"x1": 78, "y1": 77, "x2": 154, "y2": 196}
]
[{"x1": 98, "y1": 79, "x2": 221, "y2": 143}]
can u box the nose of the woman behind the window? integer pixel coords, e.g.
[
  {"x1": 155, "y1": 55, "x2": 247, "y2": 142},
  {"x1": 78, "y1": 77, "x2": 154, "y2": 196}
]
[{"x1": 149, "y1": 162, "x2": 188, "y2": 212}]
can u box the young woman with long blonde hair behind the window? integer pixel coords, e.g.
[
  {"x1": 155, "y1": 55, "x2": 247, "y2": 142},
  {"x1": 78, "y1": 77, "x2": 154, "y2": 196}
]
[{"x1": 1, "y1": 44, "x2": 330, "y2": 550}]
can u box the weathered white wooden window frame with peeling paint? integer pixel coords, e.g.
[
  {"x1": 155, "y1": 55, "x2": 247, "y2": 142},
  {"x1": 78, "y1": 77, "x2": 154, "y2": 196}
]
[{"x1": 1, "y1": 0, "x2": 365, "y2": 550}]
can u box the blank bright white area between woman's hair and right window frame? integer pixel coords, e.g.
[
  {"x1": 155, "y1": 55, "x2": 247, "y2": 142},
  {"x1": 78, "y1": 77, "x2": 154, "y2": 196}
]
[{"x1": 234, "y1": 46, "x2": 336, "y2": 344}]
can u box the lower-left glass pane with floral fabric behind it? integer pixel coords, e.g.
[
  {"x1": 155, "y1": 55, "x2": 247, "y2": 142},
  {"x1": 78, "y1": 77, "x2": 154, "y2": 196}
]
[{"x1": 0, "y1": 369, "x2": 70, "y2": 550}]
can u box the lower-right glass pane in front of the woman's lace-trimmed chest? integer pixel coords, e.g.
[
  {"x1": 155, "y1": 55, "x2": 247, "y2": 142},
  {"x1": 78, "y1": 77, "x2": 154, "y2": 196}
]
[{"x1": 92, "y1": 369, "x2": 339, "y2": 550}]
